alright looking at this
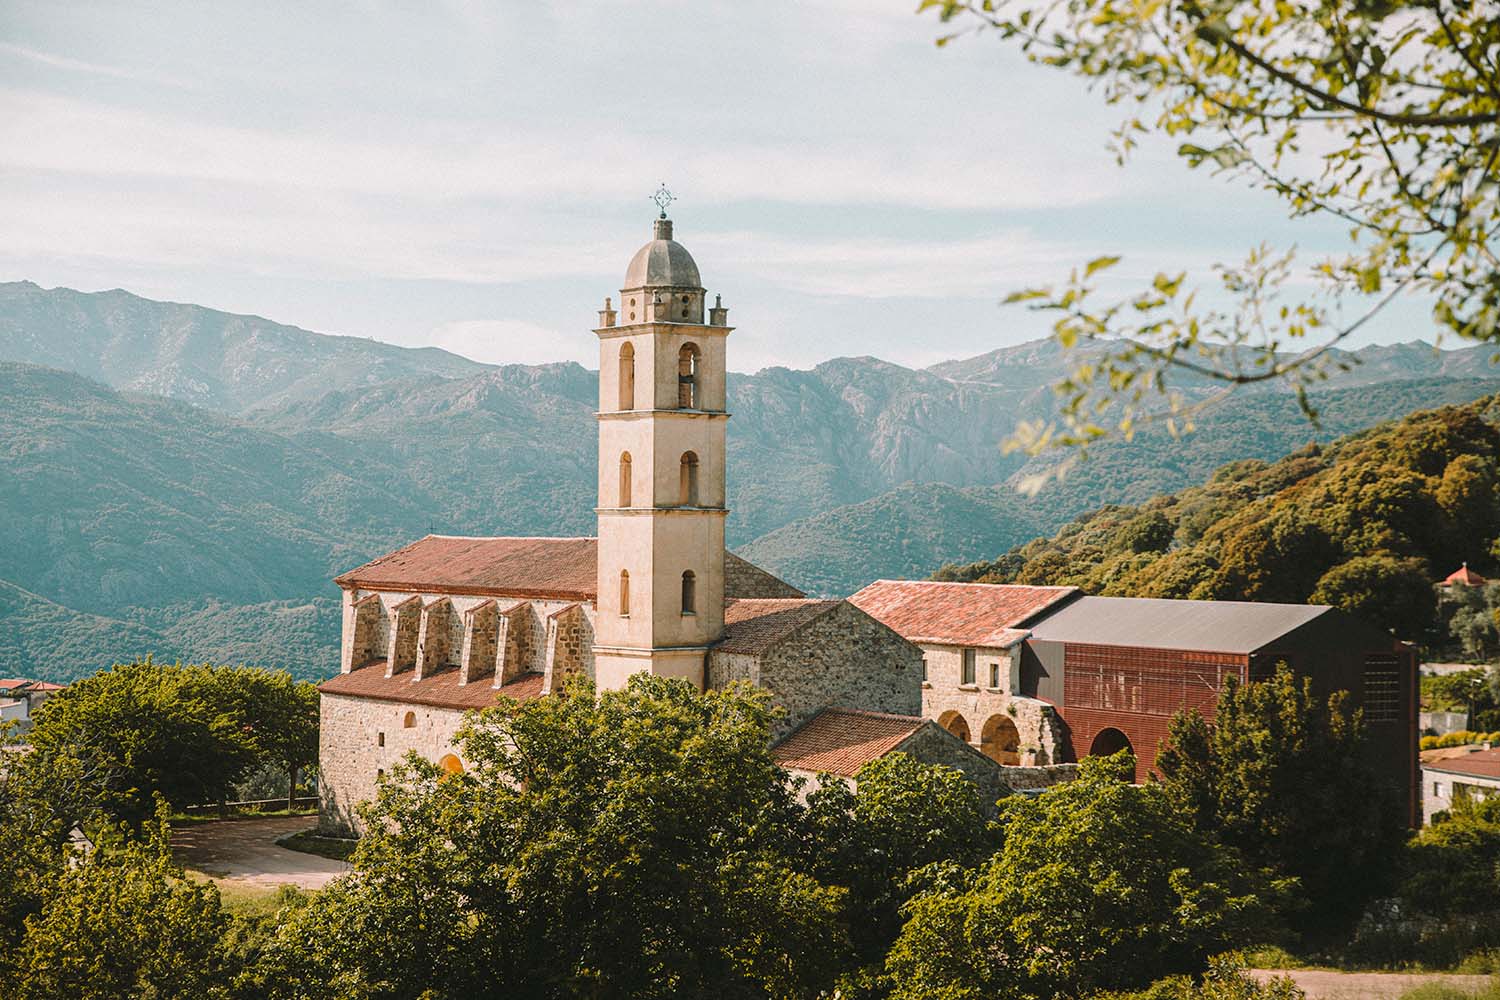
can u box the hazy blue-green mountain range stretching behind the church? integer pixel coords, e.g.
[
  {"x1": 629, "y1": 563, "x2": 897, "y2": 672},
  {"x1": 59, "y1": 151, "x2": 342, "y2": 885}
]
[{"x1": 0, "y1": 282, "x2": 1500, "y2": 678}]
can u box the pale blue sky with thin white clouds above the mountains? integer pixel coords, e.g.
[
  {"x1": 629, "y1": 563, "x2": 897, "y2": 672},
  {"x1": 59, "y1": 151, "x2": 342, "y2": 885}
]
[{"x1": 0, "y1": 0, "x2": 1452, "y2": 372}]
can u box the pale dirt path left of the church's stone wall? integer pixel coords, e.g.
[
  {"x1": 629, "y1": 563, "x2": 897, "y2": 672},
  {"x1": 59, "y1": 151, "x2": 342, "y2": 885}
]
[{"x1": 173, "y1": 816, "x2": 350, "y2": 889}]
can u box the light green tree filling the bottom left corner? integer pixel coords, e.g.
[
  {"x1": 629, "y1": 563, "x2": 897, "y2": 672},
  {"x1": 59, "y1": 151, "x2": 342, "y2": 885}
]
[{"x1": 8, "y1": 816, "x2": 234, "y2": 1000}]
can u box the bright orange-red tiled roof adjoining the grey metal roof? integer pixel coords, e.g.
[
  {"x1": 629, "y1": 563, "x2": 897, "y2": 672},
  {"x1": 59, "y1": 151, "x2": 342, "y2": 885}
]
[{"x1": 849, "y1": 580, "x2": 1079, "y2": 646}]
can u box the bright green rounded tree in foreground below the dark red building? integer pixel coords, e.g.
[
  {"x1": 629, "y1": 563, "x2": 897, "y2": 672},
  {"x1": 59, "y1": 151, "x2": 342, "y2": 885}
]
[{"x1": 887, "y1": 753, "x2": 1289, "y2": 1000}]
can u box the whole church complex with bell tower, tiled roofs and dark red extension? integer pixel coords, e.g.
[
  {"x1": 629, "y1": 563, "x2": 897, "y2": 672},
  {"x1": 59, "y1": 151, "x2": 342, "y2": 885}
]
[{"x1": 320, "y1": 211, "x2": 1419, "y2": 832}]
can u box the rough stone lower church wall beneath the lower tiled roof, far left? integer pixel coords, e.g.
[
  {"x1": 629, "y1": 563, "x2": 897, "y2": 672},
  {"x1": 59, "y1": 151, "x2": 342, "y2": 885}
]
[{"x1": 318, "y1": 694, "x2": 464, "y2": 837}]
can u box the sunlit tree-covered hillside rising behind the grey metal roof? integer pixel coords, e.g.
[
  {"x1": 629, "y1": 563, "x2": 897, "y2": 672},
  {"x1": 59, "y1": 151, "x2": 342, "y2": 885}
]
[{"x1": 939, "y1": 396, "x2": 1500, "y2": 640}]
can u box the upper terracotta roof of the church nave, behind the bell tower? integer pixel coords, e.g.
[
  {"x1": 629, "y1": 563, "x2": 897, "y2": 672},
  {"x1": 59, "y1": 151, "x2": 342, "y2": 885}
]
[{"x1": 333, "y1": 535, "x2": 801, "y2": 601}]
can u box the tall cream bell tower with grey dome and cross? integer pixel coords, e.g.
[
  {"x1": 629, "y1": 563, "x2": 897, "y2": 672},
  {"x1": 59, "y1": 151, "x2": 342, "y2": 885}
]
[{"x1": 594, "y1": 199, "x2": 731, "y2": 690}]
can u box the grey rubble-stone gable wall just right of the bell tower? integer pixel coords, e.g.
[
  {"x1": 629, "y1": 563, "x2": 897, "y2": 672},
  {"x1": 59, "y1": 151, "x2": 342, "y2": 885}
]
[{"x1": 756, "y1": 601, "x2": 923, "y2": 741}]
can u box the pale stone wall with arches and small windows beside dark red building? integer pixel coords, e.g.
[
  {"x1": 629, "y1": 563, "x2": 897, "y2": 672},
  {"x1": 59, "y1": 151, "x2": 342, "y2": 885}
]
[{"x1": 921, "y1": 643, "x2": 1067, "y2": 766}]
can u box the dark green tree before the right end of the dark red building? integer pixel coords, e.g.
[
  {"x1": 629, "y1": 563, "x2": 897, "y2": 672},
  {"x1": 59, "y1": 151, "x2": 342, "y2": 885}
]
[{"x1": 1157, "y1": 664, "x2": 1406, "y2": 927}]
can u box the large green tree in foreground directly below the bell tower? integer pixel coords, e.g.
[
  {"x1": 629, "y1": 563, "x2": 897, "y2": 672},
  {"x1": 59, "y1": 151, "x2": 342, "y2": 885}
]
[{"x1": 261, "y1": 675, "x2": 848, "y2": 997}]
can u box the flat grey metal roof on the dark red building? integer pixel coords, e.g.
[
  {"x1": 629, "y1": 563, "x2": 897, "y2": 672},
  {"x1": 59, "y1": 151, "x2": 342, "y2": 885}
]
[{"x1": 1032, "y1": 597, "x2": 1332, "y2": 654}]
